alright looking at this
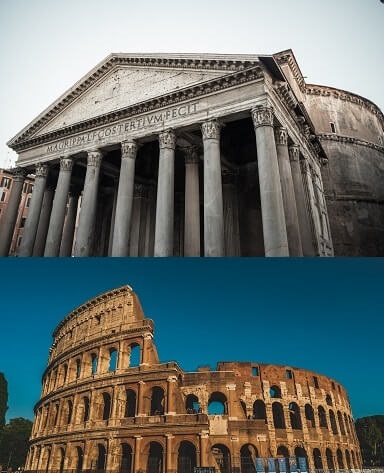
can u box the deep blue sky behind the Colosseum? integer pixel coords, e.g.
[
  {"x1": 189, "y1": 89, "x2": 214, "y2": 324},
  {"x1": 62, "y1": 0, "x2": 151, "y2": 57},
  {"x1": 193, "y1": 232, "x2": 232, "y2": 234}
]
[{"x1": 0, "y1": 258, "x2": 384, "y2": 419}]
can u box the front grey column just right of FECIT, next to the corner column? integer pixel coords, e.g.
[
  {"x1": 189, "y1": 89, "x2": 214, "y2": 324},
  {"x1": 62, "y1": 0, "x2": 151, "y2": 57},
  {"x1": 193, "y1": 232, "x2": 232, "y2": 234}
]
[{"x1": 201, "y1": 120, "x2": 224, "y2": 256}]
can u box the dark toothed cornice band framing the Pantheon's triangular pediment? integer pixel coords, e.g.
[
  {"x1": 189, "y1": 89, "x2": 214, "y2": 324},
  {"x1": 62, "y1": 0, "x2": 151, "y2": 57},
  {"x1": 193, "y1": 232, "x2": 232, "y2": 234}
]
[{"x1": 7, "y1": 63, "x2": 263, "y2": 151}]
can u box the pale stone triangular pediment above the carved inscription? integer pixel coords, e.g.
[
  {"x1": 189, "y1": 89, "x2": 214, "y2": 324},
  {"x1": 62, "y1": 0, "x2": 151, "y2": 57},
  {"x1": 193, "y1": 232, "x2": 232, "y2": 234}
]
[{"x1": 8, "y1": 54, "x2": 258, "y2": 147}]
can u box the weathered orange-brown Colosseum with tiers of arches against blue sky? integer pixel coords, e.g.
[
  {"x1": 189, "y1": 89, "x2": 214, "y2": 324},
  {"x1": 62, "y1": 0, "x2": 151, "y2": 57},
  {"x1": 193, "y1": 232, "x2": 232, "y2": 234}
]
[{"x1": 25, "y1": 286, "x2": 361, "y2": 473}]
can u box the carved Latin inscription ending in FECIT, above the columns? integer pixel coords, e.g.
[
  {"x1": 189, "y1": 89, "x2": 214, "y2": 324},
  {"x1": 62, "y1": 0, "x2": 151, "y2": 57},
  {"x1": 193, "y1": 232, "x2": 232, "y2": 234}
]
[{"x1": 47, "y1": 103, "x2": 198, "y2": 153}]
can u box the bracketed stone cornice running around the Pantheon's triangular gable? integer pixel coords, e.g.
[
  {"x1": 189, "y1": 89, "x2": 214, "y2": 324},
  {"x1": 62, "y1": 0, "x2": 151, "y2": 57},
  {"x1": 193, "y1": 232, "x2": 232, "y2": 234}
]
[{"x1": 8, "y1": 62, "x2": 264, "y2": 151}]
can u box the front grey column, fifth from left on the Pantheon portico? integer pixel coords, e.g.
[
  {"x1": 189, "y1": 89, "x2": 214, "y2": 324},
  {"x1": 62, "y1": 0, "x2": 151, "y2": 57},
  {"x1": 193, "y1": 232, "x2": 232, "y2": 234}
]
[{"x1": 112, "y1": 140, "x2": 137, "y2": 256}]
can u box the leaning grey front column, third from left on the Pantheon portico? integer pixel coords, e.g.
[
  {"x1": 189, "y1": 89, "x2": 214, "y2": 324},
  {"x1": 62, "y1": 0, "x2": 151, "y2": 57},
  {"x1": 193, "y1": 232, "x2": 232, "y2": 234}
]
[{"x1": 44, "y1": 157, "x2": 73, "y2": 256}]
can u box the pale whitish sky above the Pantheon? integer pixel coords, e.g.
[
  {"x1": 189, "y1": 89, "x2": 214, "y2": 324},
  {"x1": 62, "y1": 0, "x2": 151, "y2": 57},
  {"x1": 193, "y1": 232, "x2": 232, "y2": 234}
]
[{"x1": 0, "y1": 0, "x2": 384, "y2": 167}]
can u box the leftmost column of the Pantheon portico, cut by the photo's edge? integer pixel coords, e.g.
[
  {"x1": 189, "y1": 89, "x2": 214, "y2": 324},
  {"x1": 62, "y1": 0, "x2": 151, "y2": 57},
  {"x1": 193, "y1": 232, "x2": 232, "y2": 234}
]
[{"x1": 0, "y1": 168, "x2": 27, "y2": 256}]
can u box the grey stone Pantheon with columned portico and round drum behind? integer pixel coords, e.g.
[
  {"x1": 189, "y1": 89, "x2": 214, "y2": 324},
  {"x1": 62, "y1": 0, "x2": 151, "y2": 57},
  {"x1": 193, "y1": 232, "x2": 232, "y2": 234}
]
[{"x1": 0, "y1": 50, "x2": 384, "y2": 256}]
